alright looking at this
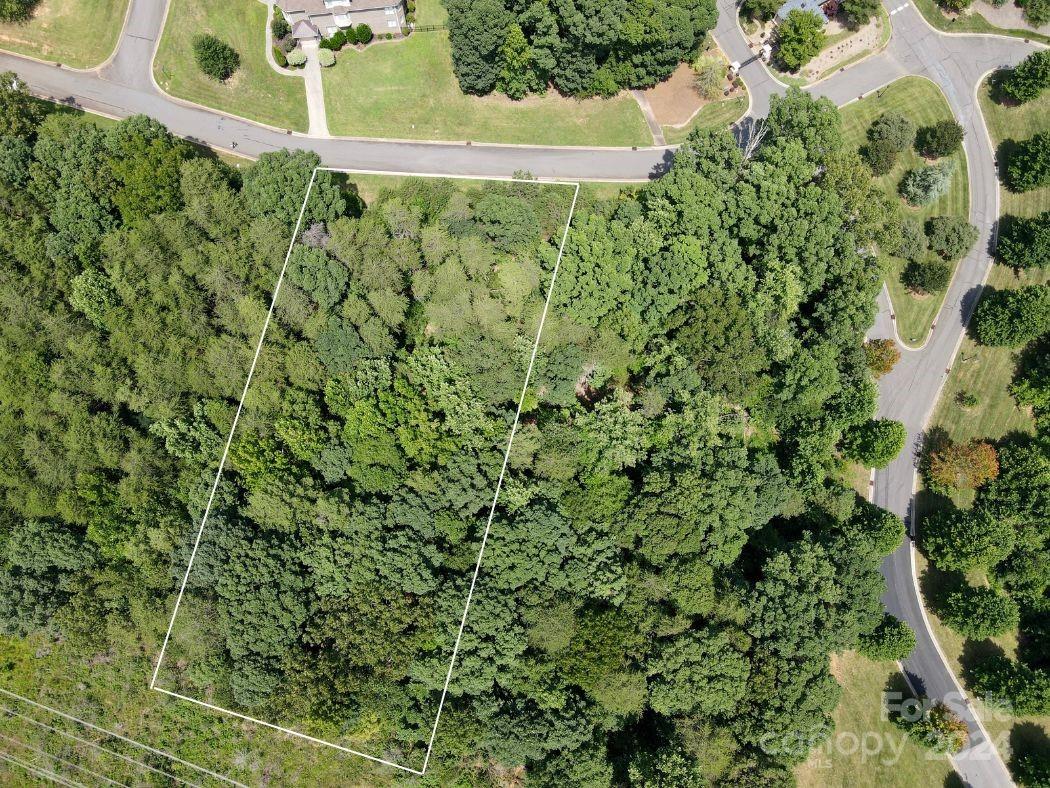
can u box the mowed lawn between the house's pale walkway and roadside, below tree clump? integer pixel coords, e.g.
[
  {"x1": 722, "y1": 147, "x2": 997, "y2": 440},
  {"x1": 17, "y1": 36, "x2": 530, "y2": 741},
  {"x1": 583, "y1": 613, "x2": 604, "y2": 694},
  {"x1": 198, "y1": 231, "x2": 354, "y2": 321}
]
[{"x1": 321, "y1": 0, "x2": 652, "y2": 146}]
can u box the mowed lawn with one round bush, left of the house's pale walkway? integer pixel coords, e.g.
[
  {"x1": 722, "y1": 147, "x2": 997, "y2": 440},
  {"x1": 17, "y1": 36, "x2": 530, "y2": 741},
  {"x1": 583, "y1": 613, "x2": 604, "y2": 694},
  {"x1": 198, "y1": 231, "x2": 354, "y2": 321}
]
[{"x1": 153, "y1": 0, "x2": 309, "y2": 131}]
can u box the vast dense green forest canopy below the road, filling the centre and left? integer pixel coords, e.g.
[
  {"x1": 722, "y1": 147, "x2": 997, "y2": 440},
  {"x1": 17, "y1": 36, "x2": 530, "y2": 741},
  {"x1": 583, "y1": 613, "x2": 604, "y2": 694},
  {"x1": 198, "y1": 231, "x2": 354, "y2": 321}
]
[{"x1": 0, "y1": 83, "x2": 903, "y2": 786}]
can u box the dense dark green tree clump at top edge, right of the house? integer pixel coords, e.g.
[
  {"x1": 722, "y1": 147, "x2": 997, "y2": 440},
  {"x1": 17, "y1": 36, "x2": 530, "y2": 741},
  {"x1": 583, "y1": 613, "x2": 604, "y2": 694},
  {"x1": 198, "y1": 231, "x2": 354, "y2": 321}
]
[{"x1": 445, "y1": 0, "x2": 718, "y2": 99}]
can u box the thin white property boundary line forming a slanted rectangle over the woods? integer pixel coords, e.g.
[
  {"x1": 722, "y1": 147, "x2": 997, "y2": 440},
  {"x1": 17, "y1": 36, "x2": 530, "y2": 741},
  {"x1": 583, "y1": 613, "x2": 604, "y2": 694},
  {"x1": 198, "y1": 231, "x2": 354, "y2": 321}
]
[{"x1": 149, "y1": 167, "x2": 580, "y2": 775}]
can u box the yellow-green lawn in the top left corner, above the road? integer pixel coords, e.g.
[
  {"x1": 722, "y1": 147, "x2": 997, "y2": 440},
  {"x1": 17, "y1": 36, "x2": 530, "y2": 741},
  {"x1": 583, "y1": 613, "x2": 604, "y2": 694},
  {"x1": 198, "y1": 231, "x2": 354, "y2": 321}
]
[{"x1": 0, "y1": 0, "x2": 128, "y2": 68}]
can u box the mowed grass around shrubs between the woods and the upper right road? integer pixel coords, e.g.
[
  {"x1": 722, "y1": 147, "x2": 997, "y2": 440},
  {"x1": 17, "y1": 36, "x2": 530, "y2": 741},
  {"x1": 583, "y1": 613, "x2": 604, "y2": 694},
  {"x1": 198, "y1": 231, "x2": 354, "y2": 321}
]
[{"x1": 841, "y1": 77, "x2": 970, "y2": 346}]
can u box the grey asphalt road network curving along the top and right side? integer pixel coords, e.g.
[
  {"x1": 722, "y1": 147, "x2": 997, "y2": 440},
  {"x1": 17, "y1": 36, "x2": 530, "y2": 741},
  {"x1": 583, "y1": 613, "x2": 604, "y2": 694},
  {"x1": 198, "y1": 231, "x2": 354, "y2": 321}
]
[{"x1": 0, "y1": 0, "x2": 1034, "y2": 786}]
